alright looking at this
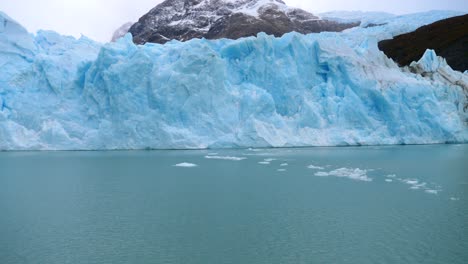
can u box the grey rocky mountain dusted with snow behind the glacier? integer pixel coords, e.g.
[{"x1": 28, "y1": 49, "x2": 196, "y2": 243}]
[{"x1": 129, "y1": 0, "x2": 359, "y2": 44}]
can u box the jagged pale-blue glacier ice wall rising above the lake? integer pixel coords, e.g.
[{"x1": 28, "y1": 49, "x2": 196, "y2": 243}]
[{"x1": 0, "y1": 11, "x2": 468, "y2": 150}]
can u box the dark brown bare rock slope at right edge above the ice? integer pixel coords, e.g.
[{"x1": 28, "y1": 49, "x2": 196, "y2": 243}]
[{"x1": 379, "y1": 15, "x2": 468, "y2": 71}]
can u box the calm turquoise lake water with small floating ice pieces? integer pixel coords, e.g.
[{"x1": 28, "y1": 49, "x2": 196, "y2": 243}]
[{"x1": 0, "y1": 145, "x2": 468, "y2": 264}]
